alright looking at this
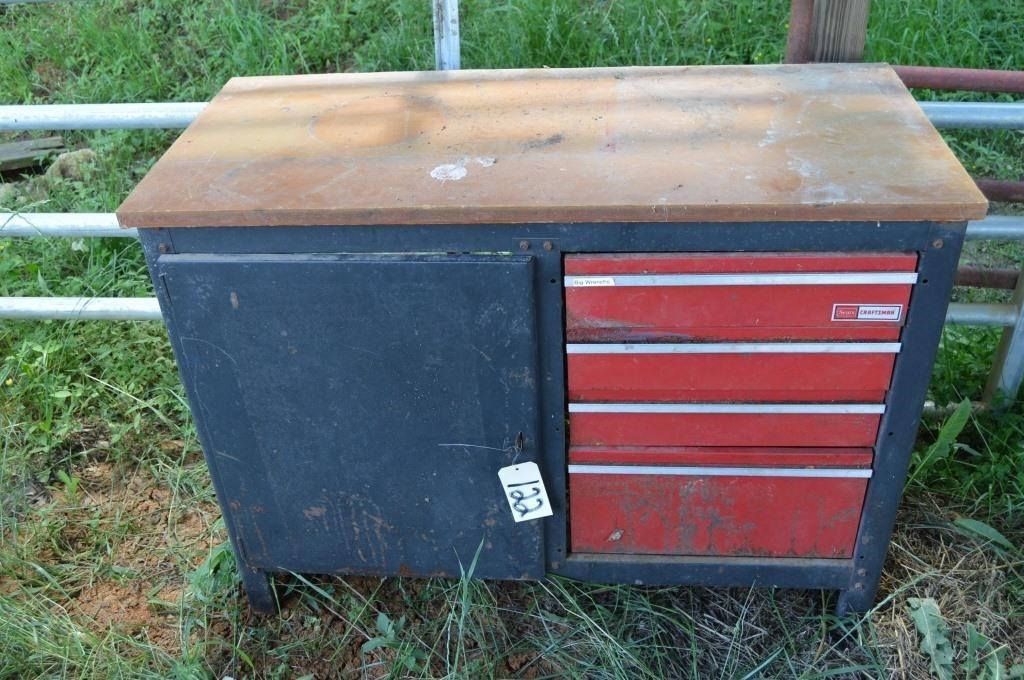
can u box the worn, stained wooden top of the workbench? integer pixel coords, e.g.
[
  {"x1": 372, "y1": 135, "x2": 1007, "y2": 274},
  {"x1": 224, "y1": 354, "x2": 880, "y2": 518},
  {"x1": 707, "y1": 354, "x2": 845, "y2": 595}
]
[{"x1": 118, "y1": 65, "x2": 986, "y2": 227}]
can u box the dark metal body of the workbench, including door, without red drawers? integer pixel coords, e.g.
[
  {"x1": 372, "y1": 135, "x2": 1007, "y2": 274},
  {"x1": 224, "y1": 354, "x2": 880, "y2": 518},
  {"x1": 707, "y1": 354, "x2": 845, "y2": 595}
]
[{"x1": 140, "y1": 222, "x2": 964, "y2": 611}]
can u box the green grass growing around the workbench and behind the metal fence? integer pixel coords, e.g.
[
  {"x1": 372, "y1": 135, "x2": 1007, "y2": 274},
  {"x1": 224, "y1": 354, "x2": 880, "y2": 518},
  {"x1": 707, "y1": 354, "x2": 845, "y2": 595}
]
[{"x1": 0, "y1": 0, "x2": 1024, "y2": 679}]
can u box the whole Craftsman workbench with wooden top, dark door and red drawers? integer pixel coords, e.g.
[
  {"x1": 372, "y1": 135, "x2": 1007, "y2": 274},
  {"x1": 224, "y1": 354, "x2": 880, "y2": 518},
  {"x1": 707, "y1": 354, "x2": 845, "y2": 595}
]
[{"x1": 119, "y1": 66, "x2": 984, "y2": 612}]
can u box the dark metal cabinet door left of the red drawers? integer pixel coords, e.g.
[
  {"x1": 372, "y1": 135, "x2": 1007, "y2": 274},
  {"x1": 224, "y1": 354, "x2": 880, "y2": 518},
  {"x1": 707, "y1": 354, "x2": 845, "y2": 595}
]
[{"x1": 157, "y1": 255, "x2": 558, "y2": 579}]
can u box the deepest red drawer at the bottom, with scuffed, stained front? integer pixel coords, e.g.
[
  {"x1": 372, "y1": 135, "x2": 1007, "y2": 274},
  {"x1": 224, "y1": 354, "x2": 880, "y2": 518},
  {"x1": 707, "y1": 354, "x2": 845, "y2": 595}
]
[{"x1": 568, "y1": 449, "x2": 870, "y2": 558}]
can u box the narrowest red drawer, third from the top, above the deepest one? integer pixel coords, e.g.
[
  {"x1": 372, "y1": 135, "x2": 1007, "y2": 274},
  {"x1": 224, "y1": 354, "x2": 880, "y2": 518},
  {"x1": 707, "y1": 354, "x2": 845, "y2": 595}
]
[{"x1": 569, "y1": 402, "x2": 885, "y2": 447}]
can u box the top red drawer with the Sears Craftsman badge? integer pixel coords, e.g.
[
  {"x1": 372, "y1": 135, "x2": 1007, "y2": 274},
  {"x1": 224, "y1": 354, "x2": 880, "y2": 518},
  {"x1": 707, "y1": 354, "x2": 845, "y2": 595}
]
[{"x1": 564, "y1": 253, "x2": 918, "y2": 342}]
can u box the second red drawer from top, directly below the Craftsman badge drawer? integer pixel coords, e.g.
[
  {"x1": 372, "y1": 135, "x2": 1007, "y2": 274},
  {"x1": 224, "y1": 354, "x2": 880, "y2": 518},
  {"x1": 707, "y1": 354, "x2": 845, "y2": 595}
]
[{"x1": 566, "y1": 342, "x2": 900, "y2": 401}]
